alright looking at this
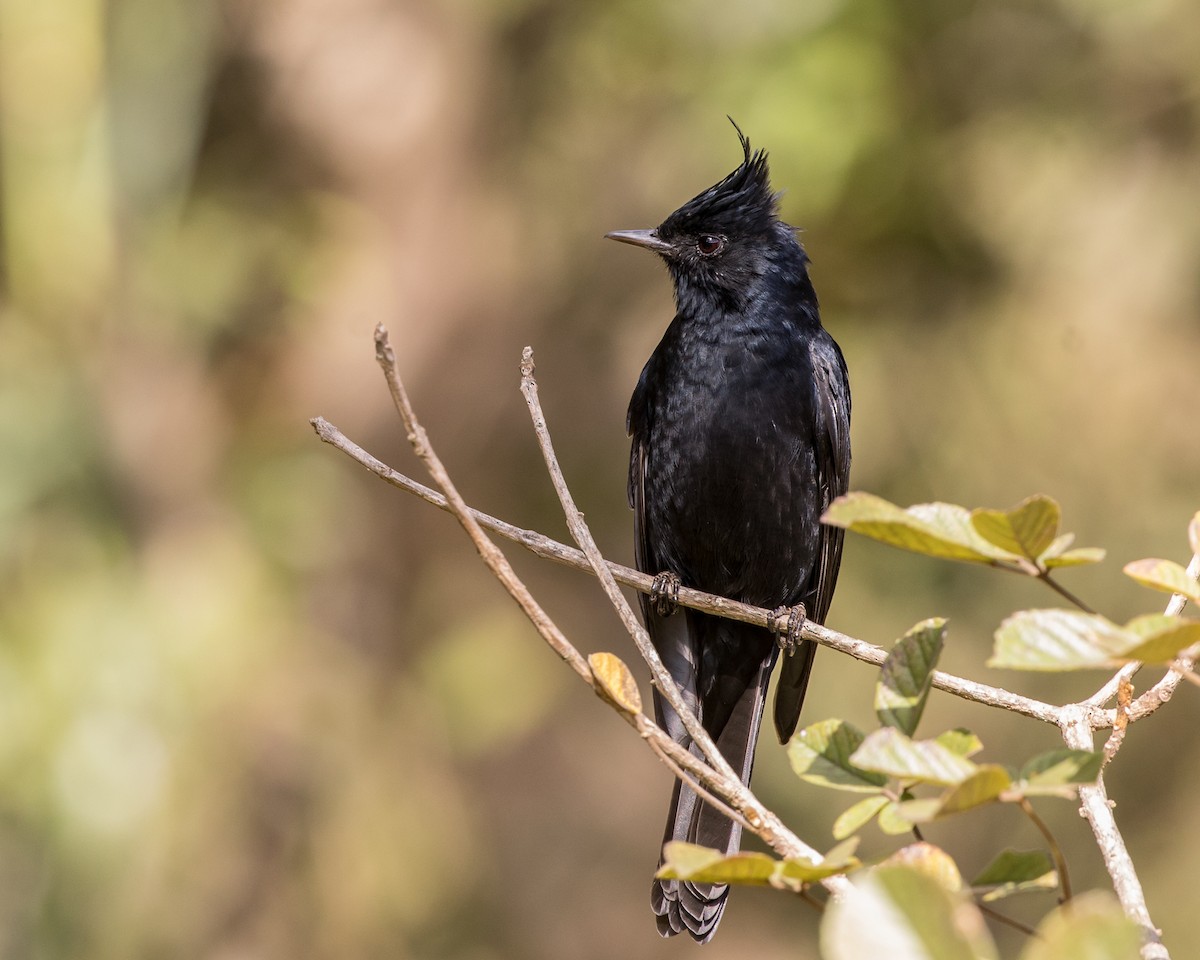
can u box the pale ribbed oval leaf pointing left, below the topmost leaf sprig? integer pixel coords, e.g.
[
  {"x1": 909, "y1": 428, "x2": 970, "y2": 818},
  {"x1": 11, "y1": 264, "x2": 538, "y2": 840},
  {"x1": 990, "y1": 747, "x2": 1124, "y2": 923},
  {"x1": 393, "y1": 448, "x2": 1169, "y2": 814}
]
[{"x1": 988, "y1": 610, "x2": 1134, "y2": 670}]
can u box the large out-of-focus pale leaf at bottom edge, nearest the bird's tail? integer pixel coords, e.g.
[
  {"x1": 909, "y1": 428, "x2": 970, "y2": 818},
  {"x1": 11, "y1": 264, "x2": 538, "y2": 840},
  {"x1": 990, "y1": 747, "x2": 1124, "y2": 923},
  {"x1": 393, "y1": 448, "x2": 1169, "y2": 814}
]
[{"x1": 821, "y1": 866, "x2": 997, "y2": 960}]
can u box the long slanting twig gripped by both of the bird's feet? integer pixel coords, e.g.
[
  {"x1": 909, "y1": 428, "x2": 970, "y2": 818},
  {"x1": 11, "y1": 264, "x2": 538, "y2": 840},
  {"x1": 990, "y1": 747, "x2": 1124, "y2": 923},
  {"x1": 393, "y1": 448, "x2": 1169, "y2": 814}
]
[{"x1": 310, "y1": 416, "x2": 1061, "y2": 726}]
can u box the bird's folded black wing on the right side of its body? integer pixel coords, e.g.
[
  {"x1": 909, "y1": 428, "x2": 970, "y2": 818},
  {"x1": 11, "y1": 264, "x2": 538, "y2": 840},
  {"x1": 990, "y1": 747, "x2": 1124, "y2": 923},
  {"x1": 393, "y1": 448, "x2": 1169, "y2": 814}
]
[{"x1": 775, "y1": 337, "x2": 850, "y2": 743}]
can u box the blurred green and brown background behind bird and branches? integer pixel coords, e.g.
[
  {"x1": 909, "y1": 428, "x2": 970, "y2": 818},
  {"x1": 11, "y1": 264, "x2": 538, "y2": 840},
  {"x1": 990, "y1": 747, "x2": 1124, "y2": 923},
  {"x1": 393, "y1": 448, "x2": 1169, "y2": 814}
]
[{"x1": 0, "y1": 0, "x2": 1200, "y2": 960}]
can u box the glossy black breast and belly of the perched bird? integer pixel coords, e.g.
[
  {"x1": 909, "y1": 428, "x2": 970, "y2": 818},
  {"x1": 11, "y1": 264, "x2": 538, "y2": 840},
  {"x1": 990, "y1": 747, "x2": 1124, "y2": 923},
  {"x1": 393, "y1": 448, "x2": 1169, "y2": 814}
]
[{"x1": 644, "y1": 326, "x2": 820, "y2": 605}]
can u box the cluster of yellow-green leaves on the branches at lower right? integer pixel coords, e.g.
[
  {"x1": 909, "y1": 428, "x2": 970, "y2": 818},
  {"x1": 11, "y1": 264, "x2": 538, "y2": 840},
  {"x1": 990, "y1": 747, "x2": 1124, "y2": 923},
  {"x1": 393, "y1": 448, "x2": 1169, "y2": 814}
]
[{"x1": 659, "y1": 493, "x2": 1200, "y2": 960}]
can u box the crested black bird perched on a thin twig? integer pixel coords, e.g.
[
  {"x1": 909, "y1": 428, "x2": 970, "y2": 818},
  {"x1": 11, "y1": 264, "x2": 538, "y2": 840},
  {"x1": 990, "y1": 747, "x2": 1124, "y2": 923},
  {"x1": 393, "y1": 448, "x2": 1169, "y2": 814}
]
[{"x1": 607, "y1": 124, "x2": 850, "y2": 943}]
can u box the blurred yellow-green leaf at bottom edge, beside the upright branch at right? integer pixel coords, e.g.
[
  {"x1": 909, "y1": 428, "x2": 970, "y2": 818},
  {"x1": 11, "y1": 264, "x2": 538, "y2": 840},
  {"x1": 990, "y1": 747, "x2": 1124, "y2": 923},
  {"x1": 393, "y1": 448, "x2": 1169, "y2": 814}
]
[{"x1": 1022, "y1": 890, "x2": 1141, "y2": 960}]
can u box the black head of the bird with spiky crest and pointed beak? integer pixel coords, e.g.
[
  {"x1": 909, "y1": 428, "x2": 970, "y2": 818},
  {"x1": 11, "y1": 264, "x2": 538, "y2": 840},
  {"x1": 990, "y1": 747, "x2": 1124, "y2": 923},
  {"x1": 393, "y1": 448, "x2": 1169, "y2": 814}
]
[{"x1": 605, "y1": 120, "x2": 804, "y2": 307}]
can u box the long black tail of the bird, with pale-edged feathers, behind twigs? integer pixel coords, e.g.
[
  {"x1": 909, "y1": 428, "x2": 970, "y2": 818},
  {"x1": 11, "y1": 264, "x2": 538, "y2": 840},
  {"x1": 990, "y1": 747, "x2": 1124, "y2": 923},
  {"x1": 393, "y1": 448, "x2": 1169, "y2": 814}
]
[{"x1": 650, "y1": 660, "x2": 772, "y2": 943}]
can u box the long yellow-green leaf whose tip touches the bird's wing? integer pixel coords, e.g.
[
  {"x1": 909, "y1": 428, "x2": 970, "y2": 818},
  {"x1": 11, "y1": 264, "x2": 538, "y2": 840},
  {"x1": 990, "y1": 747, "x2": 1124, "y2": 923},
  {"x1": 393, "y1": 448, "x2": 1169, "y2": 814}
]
[{"x1": 821, "y1": 492, "x2": 1015, "y2": 563}]
